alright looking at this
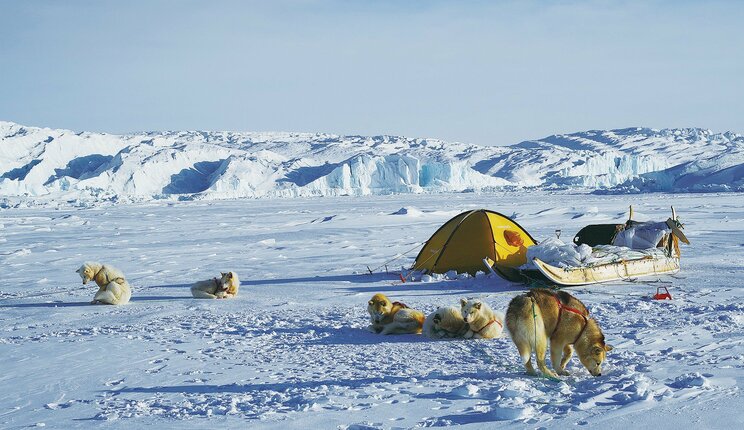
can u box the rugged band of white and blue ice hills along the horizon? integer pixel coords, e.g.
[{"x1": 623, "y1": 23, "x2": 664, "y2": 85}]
[{"x1": 0, "y1": 121, "x2": 744, "y2": 207}]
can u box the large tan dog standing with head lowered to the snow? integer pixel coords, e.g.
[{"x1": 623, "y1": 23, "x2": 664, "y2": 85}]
[{"x1": 506, "y1": 289, "x2": 612, "y2": 377}]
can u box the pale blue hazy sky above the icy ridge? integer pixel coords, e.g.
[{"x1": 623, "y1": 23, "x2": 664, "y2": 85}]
[{"x1": 0, "y1": 0, "x2": 744, "y2": 145}]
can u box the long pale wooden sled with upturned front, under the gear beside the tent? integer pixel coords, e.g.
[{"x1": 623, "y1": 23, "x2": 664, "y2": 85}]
[{"x1": 533, "y1": 256, "x2": 679, "y2": 287}]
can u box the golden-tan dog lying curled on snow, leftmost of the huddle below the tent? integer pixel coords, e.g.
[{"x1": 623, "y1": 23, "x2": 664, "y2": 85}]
[{"x1": 367, "y1": 293, "x2": 424, "y2": 334}]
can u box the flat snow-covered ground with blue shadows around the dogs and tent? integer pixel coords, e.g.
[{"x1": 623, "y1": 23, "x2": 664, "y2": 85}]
[{"x1": 0, "y1": 191, "x2": 744, "y2": 429}]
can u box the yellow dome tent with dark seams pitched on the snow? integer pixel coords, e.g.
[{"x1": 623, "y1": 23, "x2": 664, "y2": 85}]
[{"x1": 413, "y1": 209, "x2": 535, "y2": 274}]
